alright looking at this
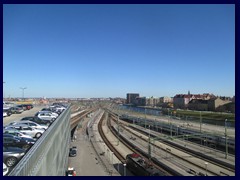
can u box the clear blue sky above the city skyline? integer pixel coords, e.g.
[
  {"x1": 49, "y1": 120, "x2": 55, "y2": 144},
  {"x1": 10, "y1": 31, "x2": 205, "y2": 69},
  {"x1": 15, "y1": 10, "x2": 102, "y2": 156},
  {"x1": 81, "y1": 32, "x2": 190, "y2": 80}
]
[{"x1": 3, "y1": 4, "x2": 235, "y2": 98}]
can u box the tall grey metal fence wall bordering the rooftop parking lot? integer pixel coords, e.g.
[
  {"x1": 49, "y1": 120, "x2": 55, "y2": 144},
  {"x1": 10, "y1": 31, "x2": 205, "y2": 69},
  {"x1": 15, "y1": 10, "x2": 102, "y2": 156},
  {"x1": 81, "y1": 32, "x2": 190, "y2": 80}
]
[{"x1": 9, "y1": 106, "x2": 71, "y2": 176}]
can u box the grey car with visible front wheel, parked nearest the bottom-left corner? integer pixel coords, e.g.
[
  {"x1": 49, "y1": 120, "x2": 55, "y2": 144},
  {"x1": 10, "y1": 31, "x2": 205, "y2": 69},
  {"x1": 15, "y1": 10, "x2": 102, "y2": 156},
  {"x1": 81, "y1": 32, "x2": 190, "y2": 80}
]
[{"x1": 3, "y1": 146, "x2": 25, "y2": 167}]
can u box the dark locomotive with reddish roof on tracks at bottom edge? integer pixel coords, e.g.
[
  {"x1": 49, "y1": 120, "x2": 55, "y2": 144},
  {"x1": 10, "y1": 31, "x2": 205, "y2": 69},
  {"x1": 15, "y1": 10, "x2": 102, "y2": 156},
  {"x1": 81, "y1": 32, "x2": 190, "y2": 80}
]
[{"x1": 126, "y1": 153, "x2": 164, "y2": 176}]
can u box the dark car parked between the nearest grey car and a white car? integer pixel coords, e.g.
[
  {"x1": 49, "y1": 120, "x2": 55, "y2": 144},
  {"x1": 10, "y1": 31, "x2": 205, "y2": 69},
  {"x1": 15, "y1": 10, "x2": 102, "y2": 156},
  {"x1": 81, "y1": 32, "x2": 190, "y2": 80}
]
[{"x1": 3, "y1": 134, "x2": 35, "y2": 150}]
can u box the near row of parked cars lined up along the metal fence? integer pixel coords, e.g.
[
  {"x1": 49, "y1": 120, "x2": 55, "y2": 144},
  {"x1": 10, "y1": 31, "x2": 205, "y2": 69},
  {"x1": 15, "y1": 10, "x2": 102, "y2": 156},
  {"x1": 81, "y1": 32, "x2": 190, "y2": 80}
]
[{"x1": 3, "y1": 104, "x2": 67, "y2": 174}]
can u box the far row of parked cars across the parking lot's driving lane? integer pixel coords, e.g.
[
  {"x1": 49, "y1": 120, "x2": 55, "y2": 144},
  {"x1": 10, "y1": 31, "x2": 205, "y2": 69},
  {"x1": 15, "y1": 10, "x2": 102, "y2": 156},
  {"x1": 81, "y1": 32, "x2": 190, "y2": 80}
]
[{"x1": 3, "y1": 104, "x2": 33, "y2": 117}]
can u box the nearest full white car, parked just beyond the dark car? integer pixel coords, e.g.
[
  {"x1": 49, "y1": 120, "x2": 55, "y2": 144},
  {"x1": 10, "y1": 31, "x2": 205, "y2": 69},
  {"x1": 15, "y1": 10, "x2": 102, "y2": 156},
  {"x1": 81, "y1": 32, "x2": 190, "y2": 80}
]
[{"x1": 5, "y1": 124, "x2": 44, "y2": 138}]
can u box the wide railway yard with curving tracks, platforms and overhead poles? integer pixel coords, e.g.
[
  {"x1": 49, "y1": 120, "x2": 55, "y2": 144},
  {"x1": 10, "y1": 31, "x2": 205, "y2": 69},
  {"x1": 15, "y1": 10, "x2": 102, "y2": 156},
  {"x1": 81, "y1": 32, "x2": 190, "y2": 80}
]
[{"x1": 69, "y1": 104, "x2": 235, "y2": 176}]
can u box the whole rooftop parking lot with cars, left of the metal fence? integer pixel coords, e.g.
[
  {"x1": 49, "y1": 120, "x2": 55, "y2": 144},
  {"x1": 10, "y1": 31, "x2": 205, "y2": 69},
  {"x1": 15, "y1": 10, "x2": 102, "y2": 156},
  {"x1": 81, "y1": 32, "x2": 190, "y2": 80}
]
[{"x1": 3, "y1": 103, "x2": 67, "y2": 175}]
